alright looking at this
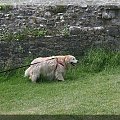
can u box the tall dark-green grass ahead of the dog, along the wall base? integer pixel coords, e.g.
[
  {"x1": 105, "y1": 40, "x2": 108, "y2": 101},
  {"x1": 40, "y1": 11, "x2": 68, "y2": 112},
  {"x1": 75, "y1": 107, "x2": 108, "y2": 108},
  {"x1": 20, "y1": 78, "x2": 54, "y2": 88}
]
[{"x1": 66, "y1": 49, "x2": 120, "y2": 80}]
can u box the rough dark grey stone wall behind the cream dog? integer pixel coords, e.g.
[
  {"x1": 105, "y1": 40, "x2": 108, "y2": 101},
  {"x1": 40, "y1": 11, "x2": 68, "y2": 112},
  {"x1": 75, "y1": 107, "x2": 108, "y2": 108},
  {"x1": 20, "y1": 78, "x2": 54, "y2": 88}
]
[{"x1": 0, "y1": 5, "x2": 120, "y2": 68}]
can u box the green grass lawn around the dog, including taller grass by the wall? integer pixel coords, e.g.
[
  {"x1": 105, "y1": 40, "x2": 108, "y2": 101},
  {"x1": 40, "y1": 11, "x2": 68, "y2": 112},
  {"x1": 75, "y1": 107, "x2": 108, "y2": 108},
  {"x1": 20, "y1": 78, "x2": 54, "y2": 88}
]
[{"x1": 0, "y1": 51, "x2": 120, "y2": 115}]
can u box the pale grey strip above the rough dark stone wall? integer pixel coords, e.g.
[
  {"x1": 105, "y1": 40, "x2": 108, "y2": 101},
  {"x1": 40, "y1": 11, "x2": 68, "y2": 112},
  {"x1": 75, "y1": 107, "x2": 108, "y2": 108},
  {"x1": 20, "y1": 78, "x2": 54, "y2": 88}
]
[{"x1": 0, "y1": 0, "x2": 120, "y2": 6}]
